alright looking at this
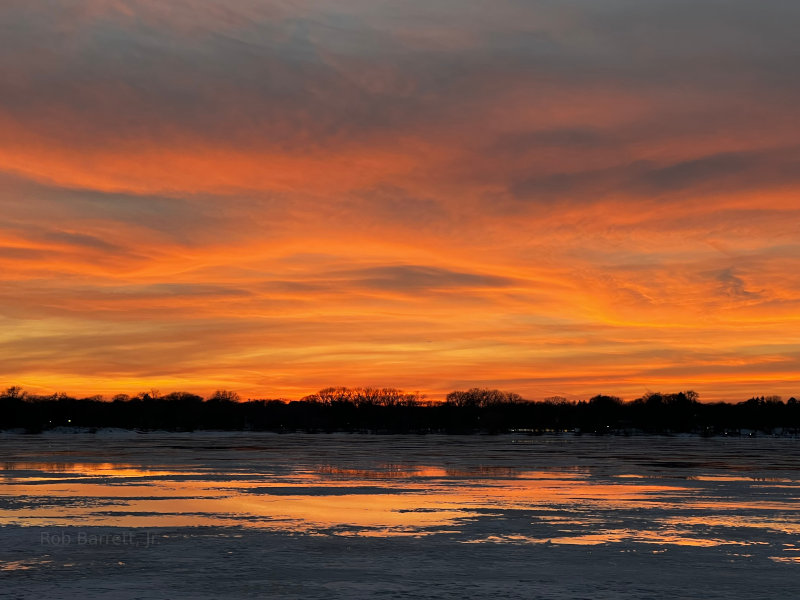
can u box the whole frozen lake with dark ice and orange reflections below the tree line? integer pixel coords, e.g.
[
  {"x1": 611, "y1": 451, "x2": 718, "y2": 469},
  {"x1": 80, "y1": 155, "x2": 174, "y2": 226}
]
[{"x1": 0, "y1": 431, "x2": 800, "y2": 599}]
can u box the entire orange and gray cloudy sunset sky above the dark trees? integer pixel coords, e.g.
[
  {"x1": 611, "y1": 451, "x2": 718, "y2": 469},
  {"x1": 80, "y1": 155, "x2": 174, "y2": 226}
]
[{"x1": 0, "y1": 0, "x2": 800, "y2": 401}]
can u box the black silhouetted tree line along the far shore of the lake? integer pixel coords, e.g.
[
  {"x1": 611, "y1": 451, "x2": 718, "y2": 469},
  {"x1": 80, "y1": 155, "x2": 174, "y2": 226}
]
[{"x1": 0, "y1": 386, "x2": 800, "y2": 436}]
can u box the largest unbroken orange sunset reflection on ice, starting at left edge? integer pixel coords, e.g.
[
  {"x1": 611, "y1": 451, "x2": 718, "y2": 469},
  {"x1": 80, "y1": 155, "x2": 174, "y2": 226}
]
[{"x1": 0, "y1": 464, "x2": 685, "y2": 535}]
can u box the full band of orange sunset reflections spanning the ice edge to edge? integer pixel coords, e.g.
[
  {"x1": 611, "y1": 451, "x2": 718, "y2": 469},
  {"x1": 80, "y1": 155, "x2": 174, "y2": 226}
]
[{"x1": 0, "y1": 462, "x2": 800, "y2": 546}]
